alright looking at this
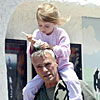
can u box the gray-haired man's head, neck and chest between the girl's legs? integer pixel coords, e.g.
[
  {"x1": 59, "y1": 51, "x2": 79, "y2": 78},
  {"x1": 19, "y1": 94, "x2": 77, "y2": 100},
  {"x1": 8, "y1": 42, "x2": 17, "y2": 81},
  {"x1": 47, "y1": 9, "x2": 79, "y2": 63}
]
[{"x1": 31, "y1": 50, "x2": 82, "y2": 100}]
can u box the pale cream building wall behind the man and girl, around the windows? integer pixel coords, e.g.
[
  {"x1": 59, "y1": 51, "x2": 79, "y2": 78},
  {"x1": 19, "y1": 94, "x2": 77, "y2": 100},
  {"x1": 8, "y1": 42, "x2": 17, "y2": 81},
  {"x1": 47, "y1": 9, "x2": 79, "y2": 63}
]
[{"x1": 0, "y1": 0, "x2": 100, "y2": 100}]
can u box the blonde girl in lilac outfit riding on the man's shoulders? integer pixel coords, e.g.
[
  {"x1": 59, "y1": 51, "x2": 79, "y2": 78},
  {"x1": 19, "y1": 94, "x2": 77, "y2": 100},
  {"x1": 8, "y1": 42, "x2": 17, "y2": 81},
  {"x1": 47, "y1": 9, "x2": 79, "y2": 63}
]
[{"x1": 23, "y1": 3, "x2": 82, "y2": 100}]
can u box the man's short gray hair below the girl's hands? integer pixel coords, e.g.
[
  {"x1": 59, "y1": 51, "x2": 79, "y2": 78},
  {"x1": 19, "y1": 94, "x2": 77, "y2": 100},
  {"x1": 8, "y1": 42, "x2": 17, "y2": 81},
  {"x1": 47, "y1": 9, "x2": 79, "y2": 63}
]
[{"x1": 31, "y1": 49, "x2": 56, "y2": 59}]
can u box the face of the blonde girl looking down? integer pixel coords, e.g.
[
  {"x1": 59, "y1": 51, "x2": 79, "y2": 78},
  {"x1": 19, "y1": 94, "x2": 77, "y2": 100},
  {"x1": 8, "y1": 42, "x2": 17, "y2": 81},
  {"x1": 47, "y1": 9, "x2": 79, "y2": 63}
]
[{"x1": 38, "y1": 20, "x2": 56, "y2": 35}]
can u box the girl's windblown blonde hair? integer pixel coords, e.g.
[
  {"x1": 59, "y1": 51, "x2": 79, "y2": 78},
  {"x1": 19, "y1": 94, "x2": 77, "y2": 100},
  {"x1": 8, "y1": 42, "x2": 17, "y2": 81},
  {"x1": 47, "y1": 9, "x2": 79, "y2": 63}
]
[{"x1": 36, "y1": 3, "x2": 66, "y2": 25}]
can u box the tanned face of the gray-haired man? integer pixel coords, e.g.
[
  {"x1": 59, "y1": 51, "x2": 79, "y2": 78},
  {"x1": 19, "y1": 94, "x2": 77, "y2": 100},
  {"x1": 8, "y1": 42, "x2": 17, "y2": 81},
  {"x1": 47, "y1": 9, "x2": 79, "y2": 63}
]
[{"x1": 33, "y1": 53, "x2": 58, "y2": 83}]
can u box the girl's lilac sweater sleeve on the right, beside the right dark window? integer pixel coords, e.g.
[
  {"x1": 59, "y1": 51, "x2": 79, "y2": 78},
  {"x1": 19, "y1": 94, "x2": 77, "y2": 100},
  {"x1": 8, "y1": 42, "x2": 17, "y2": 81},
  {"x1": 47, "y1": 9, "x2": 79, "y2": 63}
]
[{"x1": 53, "y1": 30, "x2": 70, "y2": 58}]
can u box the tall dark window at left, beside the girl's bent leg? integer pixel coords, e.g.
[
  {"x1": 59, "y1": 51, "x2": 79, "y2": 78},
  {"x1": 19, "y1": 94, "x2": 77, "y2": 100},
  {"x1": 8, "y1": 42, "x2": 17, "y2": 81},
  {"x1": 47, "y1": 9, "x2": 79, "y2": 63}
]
[{"x1": 5, "y1": 39, "x2": 27, "y2": 100}]
